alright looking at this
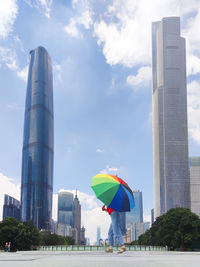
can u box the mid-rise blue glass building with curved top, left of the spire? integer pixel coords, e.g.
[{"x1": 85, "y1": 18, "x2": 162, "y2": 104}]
[{"x1": 58, "y1": 192, "x2": 73, "y2": 227}]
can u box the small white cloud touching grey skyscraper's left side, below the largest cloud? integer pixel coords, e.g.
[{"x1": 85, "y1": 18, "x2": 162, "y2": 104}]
[{"x1": 126, "y1": 67, "x2": 152, "y2": 91}]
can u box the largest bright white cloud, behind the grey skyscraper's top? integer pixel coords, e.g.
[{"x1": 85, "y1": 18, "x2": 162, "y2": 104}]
[{"x1": 94, "y1": 0, "x2": 200, "y2": 67}]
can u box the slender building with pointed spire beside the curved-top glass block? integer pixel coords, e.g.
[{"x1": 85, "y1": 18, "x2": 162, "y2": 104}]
[{"x1": 73, "y1": 191, "x2": 81, "y2": 244}]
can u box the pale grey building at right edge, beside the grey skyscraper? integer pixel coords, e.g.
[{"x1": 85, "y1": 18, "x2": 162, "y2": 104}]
[{"x1": 189, "y1": 157, "x2": 200, "y2": 216}]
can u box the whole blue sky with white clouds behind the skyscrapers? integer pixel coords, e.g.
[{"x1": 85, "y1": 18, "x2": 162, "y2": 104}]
[{"x1": 0, "y1": 0, "x2": 200, "y2": 243}]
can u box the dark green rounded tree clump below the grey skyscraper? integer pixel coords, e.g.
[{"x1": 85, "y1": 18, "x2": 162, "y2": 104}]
[{"x1": 138, "y1": 208, "x2": 200, "y2": 249}]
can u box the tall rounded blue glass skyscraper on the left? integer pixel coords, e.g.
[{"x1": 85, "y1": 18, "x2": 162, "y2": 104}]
[{"x1": 21, "y1": 47, "x2": 54, "y2": 230}]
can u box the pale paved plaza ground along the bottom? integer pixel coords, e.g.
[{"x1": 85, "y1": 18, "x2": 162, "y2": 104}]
[{"x1": 0, "y1": 251, "x2": 200, "y2": 267}]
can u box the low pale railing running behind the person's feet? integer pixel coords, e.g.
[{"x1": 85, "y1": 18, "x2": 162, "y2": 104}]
[{"x1": 37, "y1": 245, "x2": 166, "y2": 251}]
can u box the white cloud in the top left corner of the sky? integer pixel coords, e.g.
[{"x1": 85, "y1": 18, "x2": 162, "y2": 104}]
[{"x1": 0, "y1": 0, "x2": 18, "y2": 38}]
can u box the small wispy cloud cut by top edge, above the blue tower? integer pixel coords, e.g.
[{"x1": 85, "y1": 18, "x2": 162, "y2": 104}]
[{"x1": 24, "y1": 0, "x2": 53, "y2": 19}]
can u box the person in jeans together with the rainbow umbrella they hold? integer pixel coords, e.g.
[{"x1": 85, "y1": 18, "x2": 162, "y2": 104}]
[{"x1": 92, "y1": 174, "x2": 135, "y2": 253}]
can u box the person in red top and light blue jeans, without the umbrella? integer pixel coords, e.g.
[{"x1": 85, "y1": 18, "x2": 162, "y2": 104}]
[{"x1": 102, "y1": 205, "x2": 126, "y2": 253}]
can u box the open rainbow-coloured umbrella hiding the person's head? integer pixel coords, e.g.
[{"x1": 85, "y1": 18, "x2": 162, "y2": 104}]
[{"x1": 91, "y1": 174, "x2": 135, "y2": 211}]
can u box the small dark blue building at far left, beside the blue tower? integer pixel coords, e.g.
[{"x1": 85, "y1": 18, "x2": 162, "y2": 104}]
[{"x1": 3, "y1": 195, "x2": 21, "y2": 221}]
